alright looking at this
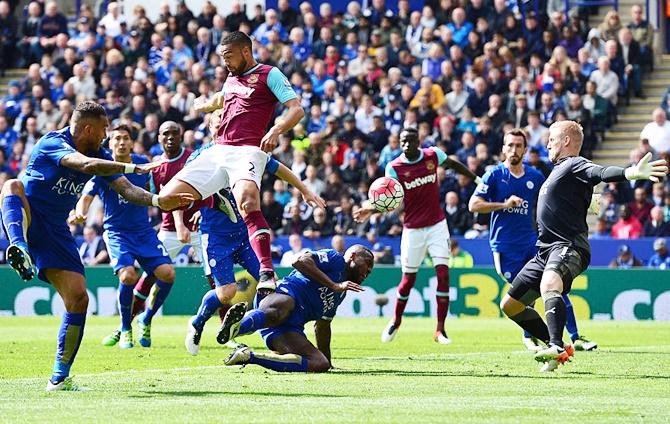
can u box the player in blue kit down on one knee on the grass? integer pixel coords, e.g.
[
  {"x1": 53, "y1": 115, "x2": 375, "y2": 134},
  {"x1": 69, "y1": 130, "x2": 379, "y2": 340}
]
[{"x1": 217, "y1": 244, "x2": 374, "y2": 372}]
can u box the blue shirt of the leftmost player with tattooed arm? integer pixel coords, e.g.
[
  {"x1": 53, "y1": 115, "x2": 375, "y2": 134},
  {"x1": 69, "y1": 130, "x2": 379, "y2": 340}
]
[{"x1": 21, "y1": 127, "x2": 121, "y2": 222}]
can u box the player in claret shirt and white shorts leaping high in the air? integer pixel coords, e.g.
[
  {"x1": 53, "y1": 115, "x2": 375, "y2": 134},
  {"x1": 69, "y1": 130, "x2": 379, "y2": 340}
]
[{"x1": 161, "y1": 31, "x2": 305, "y2": 291}]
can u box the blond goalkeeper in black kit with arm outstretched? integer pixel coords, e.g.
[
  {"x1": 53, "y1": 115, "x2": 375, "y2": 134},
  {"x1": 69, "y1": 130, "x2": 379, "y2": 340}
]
[{"x1": 500, "y1": 121, "x2": 668, "y2": 371}]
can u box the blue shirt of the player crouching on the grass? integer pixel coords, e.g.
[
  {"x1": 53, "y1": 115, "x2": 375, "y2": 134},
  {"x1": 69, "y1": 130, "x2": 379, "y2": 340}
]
[{"x1": 282, "y1": 249, "x2": 346, "y2": 322}]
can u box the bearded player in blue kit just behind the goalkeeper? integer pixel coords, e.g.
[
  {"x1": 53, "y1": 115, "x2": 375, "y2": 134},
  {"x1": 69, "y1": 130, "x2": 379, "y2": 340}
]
[{"x1": 469, "y1": 129, "x2": 598, "y2": 352}]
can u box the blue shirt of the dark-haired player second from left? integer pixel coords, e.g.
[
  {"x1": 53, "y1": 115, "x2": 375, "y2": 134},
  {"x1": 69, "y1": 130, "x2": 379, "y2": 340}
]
[{"x1": 84, "y1": 154, "x2": 150, "y2": 231}]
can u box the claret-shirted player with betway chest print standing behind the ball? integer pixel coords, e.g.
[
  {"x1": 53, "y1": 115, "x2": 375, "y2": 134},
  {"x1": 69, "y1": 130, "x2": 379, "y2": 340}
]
[{"x1": 354, "y1": 128, "x2": 479, "y2": 344}]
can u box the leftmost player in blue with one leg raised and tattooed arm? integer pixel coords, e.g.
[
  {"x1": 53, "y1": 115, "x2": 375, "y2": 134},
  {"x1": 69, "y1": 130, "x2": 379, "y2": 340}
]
[{"x1": 2, "y1": 101, "x2": 193, "y2": 391}]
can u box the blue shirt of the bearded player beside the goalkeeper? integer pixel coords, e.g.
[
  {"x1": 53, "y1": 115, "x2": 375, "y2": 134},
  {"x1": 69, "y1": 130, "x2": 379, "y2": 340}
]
[{"x1": 474, "y1": 164, "x2": 544, "y2": 254}]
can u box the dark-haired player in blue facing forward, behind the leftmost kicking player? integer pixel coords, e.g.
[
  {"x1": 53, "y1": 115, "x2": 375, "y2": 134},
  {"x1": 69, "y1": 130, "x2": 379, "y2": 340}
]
[{"x1": 70, "y1": 125, "x2": 175, "y2": 349}]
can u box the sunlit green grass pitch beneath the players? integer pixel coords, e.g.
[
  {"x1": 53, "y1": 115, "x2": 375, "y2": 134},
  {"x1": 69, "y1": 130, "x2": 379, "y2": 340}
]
[{"x1": 0, "y1": 317, "x2": 670, "y2": 423}]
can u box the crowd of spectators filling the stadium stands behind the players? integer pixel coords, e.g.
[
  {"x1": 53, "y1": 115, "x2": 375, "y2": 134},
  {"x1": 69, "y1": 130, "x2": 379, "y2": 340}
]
[{"x1": 0, "y1": 0, "x2": 670, "y2": 264}]
